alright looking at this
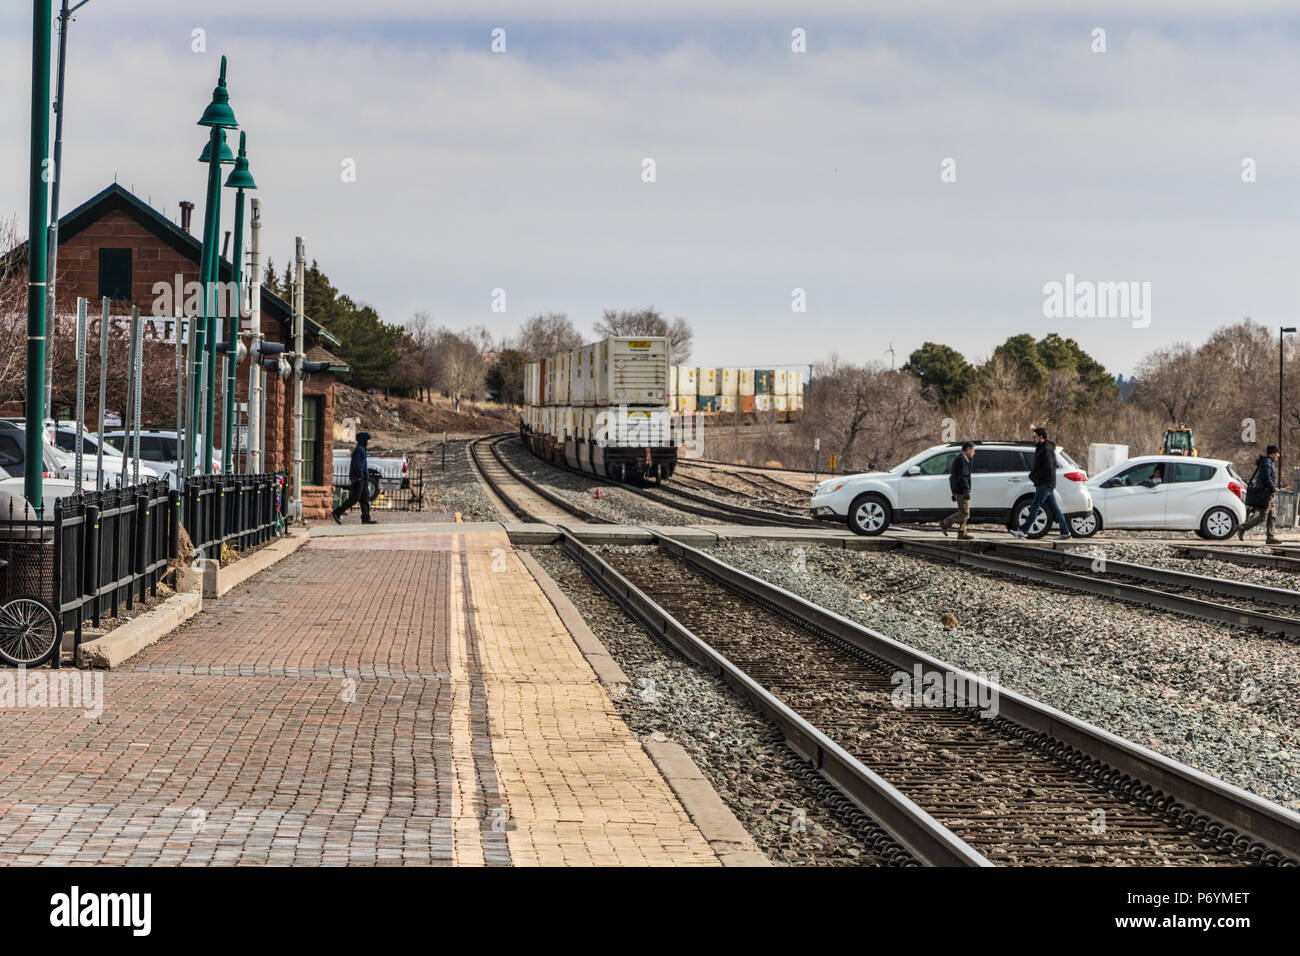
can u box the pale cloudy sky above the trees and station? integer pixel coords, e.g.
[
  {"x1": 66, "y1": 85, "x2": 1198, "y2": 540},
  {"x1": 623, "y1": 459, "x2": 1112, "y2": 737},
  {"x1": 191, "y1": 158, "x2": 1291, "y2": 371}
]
[{"x1": 0, "y1": 0, "x2": 1300, "y2": 373}]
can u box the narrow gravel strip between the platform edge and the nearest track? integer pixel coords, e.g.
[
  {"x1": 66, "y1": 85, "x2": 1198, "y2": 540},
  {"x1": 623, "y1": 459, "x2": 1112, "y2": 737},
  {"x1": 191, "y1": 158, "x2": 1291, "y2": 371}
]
[{"x1": 529, "y1": 548, "x2": 899, "y2": 866}]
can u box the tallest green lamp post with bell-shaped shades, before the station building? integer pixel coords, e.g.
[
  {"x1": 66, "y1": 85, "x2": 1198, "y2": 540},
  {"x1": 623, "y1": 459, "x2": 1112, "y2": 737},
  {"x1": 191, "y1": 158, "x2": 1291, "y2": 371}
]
[{"x1": 186, "y1": 56, "x2": 238, "y2": 473}]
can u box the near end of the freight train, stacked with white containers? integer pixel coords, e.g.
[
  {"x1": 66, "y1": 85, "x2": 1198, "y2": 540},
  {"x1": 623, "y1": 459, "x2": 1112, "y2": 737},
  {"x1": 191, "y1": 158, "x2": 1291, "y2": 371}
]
[{"x1": 520, "y1": 336, "x2": 680, "y2": 481}]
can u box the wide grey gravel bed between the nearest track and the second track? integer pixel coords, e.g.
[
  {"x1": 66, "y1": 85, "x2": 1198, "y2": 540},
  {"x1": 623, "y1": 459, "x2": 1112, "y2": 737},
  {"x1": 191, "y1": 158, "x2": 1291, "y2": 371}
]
[{"x1": 709, "y1": 544, "x2": 1300, "y2": 809}]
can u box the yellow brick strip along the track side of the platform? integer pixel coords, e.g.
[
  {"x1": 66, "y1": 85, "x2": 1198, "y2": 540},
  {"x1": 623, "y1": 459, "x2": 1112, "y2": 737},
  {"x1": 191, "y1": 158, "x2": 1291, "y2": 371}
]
[{"x1": 452, "y1": 536, "x2": 718, "y2": 866}]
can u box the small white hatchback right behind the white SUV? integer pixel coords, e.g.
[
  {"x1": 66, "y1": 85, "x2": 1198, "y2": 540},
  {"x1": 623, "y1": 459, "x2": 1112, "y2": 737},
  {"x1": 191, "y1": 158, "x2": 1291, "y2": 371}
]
[{"x1": 1069, "y1": 455, "x2": 1245, "y2": 541}]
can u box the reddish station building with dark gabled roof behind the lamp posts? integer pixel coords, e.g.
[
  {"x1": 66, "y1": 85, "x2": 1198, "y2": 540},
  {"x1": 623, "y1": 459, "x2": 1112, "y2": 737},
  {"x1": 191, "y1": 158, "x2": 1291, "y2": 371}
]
[{"x1": 20, "y1": 183, "x2": 347, "y2": 518}]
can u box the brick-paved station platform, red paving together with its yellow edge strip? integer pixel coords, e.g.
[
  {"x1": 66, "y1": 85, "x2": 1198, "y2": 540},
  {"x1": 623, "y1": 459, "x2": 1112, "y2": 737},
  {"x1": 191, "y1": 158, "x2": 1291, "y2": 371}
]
[{"x1": 0, "y1": 522, "x2": 718, "y2": 865}]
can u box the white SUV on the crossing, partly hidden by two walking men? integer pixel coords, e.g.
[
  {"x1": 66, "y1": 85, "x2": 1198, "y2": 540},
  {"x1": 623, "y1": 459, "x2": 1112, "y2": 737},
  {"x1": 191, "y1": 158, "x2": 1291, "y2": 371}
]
[{"x1": 811, "y1": 441, "x2": 1092, "y2": 537}]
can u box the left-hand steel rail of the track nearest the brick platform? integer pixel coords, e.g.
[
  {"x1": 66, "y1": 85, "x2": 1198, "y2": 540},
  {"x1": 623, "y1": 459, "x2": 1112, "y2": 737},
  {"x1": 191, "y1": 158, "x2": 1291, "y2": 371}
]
[{"x1": 560, "y1": 531, "x2": 992, "y2": 866}]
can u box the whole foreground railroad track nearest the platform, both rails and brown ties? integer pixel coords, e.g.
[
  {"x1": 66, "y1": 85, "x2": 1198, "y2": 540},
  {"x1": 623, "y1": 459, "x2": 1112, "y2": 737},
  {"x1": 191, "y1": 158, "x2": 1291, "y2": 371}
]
[{"x1": 563, "y1": 535, "x2": 1300, "y2": 866}]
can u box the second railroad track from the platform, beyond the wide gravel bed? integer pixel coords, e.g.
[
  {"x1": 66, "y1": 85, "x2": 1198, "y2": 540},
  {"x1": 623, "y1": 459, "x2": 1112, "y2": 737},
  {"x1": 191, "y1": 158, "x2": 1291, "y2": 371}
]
[{"x1": 898, "y1": 540, "x2": 1300, "y2": 639}]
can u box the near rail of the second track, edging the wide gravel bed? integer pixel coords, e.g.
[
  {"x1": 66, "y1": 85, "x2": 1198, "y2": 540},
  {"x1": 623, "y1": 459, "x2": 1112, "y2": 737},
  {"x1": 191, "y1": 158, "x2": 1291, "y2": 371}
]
[{"x1": 898, "y1": 540, "x2": 1300, "y2": 637}]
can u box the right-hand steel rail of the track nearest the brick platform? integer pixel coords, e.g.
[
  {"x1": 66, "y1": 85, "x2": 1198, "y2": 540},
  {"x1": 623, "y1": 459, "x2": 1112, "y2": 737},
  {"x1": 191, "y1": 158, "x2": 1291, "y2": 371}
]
[{"x1": 655, "y1": 533, "x2": 1300, "y2": 860}]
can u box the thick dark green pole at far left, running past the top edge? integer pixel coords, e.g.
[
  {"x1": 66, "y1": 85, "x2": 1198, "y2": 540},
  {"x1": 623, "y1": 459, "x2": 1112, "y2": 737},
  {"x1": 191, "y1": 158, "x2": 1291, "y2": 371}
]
[{"x1": 22, "y1": 0, "x2": 53, "y2": 518}]
